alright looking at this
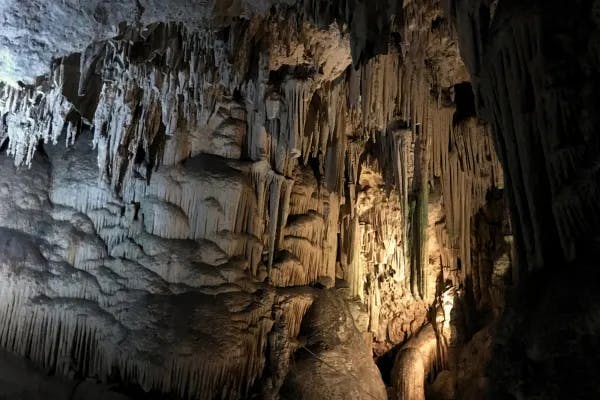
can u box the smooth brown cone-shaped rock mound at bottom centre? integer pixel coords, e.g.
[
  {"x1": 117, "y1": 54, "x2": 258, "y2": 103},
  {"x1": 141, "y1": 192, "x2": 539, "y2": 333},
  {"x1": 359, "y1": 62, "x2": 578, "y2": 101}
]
[{"x1": 281, "y1": 291, "x2": 387, "y2": 400}]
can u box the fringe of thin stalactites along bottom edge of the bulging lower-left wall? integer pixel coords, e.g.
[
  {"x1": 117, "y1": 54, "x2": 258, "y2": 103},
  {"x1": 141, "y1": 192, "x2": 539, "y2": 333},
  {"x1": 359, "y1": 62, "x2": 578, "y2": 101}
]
[{"x1": 0, "y1": 270, "x2": 276, "y2": 399}]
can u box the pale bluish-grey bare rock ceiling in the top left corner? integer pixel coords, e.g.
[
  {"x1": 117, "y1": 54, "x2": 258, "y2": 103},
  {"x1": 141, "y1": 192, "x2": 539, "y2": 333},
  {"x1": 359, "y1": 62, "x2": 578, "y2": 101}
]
[{"x1": 0, "y1": 0, "x2": 285, "y2": 83}]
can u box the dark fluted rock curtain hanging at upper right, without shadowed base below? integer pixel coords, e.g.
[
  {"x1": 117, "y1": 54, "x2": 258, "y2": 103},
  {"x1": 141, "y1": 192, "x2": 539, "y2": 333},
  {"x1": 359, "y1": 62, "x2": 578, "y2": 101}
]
[{"x1": 450, "y1": 1, "x2": 598, "y2": 273}]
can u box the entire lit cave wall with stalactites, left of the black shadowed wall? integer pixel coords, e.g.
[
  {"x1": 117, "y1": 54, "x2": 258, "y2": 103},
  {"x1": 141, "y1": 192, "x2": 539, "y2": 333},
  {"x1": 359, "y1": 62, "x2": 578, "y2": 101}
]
[{"x1": 0, "y1": 0, "x2": 510, "y2": 399}]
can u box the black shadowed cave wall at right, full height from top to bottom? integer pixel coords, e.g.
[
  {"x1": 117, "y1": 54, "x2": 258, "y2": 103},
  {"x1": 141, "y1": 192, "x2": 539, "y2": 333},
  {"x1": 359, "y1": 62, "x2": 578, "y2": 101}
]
[{"x1": 446, "y1": 1, "x2": 599, "y2": 399}]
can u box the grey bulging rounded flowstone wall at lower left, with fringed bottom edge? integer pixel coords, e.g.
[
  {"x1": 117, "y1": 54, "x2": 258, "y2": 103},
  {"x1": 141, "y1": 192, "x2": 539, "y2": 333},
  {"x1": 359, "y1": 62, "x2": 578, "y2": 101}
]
[{"x1": 0, "y1": 151, "x2": 275, "y2": 398}]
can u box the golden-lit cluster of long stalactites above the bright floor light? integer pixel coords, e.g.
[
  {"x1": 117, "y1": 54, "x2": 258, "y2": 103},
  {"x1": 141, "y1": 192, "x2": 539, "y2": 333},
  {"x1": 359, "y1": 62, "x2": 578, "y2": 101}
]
[{"x1": 341, "y1": 37, "x2": 503, "y2": 352}]
